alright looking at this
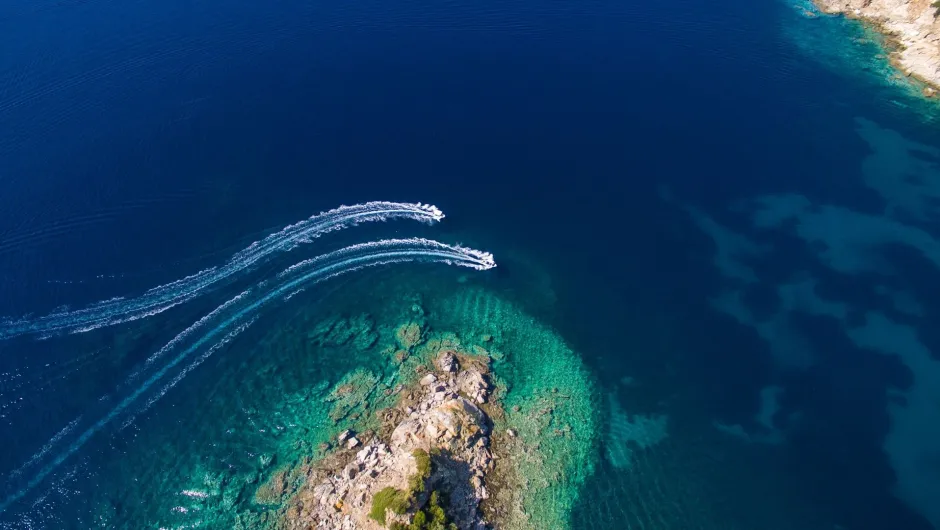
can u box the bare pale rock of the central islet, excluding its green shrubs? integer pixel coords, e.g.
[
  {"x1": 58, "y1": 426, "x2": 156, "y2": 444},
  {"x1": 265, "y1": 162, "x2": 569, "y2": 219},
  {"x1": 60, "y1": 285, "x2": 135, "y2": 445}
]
[{"x1": 281, "y1": 351, "x2": 494, "y2": 530}]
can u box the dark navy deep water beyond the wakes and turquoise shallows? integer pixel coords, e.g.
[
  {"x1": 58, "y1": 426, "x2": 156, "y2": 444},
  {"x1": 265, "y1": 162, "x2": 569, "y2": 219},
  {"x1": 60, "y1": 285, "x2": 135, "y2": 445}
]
[{"x1": 0, "y1": 0, "x2": 940, "y2": 530}]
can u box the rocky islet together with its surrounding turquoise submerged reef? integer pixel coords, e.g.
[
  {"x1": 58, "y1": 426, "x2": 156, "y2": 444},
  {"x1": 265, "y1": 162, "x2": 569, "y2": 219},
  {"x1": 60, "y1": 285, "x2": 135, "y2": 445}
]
[{"x1": 235, "y1": 288, "x2": 596, "y2": 530}]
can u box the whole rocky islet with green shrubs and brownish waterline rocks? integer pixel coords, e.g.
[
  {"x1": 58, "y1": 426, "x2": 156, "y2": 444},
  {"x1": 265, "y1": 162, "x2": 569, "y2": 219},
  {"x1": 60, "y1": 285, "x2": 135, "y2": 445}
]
[{"x1": 248, "y1": 316, "x2": 536, "y2": 530}]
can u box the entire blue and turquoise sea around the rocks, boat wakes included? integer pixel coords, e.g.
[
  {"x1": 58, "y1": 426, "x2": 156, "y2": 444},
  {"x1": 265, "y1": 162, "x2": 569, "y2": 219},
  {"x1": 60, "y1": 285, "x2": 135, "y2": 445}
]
[{"x1": 0, "y1": 0, "x2": 940, "y2": 530}]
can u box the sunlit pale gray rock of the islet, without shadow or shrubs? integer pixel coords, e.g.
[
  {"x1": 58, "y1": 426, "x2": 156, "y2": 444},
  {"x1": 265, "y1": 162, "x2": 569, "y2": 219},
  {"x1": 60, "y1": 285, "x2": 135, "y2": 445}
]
[{"x1": 289, "y1": 371, "x2": 493, "y2": 530}]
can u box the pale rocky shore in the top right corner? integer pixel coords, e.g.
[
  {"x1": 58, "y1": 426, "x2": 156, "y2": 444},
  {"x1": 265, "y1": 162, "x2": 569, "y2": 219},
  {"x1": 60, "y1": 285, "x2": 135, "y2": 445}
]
[{"x1": 815, "y1": 0, "x2": 940, "y2": 91}]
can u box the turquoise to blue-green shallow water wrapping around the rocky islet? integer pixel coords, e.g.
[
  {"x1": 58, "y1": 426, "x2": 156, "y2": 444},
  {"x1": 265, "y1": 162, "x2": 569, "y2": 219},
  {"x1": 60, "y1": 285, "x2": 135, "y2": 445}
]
[{"x1": 66, "y1": 260, "x2": 598, "y2": 528}]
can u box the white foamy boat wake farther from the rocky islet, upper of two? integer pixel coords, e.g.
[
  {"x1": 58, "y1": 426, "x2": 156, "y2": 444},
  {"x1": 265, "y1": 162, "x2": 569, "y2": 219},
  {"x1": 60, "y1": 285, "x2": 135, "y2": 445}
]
[{"x1": 0, "y1": 201, "x2": 444, "y2": 340}]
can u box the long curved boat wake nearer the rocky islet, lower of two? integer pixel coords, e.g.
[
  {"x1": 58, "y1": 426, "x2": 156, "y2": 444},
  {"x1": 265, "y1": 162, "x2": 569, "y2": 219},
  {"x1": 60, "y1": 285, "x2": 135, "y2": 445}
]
[{"x1": 0, "y1": 238, "x2": 496, "y2": 513}]
